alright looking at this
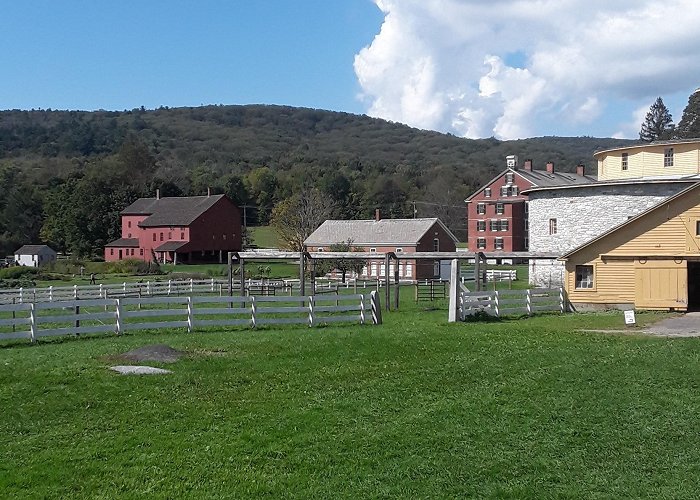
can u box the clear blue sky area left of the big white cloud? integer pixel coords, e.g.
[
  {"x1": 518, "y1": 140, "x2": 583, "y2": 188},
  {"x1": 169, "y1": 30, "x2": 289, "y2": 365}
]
[{"x1": 0, "y1": 0, "x2": 382, "y2": 113}]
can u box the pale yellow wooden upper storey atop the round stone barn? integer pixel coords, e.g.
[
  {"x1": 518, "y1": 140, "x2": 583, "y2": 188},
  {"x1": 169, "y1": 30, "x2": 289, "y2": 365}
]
[{"x1": 593, "y1": 139, "x2": 700, "y2": 181}]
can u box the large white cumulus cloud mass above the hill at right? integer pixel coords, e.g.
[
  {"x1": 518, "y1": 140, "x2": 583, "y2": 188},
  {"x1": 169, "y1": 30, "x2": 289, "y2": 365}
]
[{"x1": 354, "y1": 0, "x2": 700, "y2": 139}]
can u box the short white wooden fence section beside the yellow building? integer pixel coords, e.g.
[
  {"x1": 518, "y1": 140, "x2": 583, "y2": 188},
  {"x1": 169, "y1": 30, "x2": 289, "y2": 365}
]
[{"x1": 459, "y1": 288, "x2": 566, "y2": 321}]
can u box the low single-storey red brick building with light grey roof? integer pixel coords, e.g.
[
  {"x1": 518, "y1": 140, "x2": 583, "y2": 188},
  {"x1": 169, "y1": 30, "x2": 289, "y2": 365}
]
[{"x1": 304, "y1": 214, "x2": 457, "y2": 280}]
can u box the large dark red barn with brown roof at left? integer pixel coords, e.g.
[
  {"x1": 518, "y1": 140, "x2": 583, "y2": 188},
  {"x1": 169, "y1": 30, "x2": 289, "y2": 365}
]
[{"x1": 105, "y1": 194, "x2": 242, "y2": 264}]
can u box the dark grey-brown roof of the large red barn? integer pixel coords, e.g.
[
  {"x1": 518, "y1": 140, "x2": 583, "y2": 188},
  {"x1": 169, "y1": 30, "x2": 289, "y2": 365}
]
[{"x1": 121, "y1": 194, "x2": 225, "y2": 227}]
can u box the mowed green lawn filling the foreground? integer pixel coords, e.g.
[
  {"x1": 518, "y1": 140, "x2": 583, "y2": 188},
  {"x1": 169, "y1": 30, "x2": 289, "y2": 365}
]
[{"x1": 0, "y1": 309, "x2": 700, "y2": 498}]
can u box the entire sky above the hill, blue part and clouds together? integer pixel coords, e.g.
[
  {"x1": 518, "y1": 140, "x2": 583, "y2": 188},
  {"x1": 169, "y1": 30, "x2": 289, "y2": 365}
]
[{"x1": 0, "y1": 0, "x2": 700, "y2": 139}]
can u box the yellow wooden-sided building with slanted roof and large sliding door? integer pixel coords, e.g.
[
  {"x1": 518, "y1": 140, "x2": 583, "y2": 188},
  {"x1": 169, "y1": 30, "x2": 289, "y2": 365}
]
[{"x1": 561, "y1": 183, "x2": 700, "y2": 311}]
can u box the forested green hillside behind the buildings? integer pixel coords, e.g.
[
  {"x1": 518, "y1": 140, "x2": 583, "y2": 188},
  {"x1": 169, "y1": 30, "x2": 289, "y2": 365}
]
[{"x1": 0, "y1": 105, "x2": 630, "y2": 255}]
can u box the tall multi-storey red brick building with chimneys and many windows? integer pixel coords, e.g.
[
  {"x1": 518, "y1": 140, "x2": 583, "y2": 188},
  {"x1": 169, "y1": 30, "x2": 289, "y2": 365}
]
[{"x1": 466, "y1": 156, "x2": 596, "y2": 252}]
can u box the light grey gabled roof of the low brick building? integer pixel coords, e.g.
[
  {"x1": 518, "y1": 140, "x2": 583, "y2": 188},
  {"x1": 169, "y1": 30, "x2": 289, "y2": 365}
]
[{"x1": 304, "y1": 218, "x2": 457, "y2": 246}]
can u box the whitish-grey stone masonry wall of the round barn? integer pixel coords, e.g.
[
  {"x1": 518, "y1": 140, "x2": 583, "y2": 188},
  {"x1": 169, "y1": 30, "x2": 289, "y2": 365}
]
[{"x1": 528, "y1": 183, "x2": 688, "y2": 287}]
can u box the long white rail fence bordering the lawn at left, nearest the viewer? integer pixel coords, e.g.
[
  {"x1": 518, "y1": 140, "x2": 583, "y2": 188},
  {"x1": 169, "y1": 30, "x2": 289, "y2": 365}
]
[{"x1": 0, "y1": 292, "x2": 381, "y2": 342}]
